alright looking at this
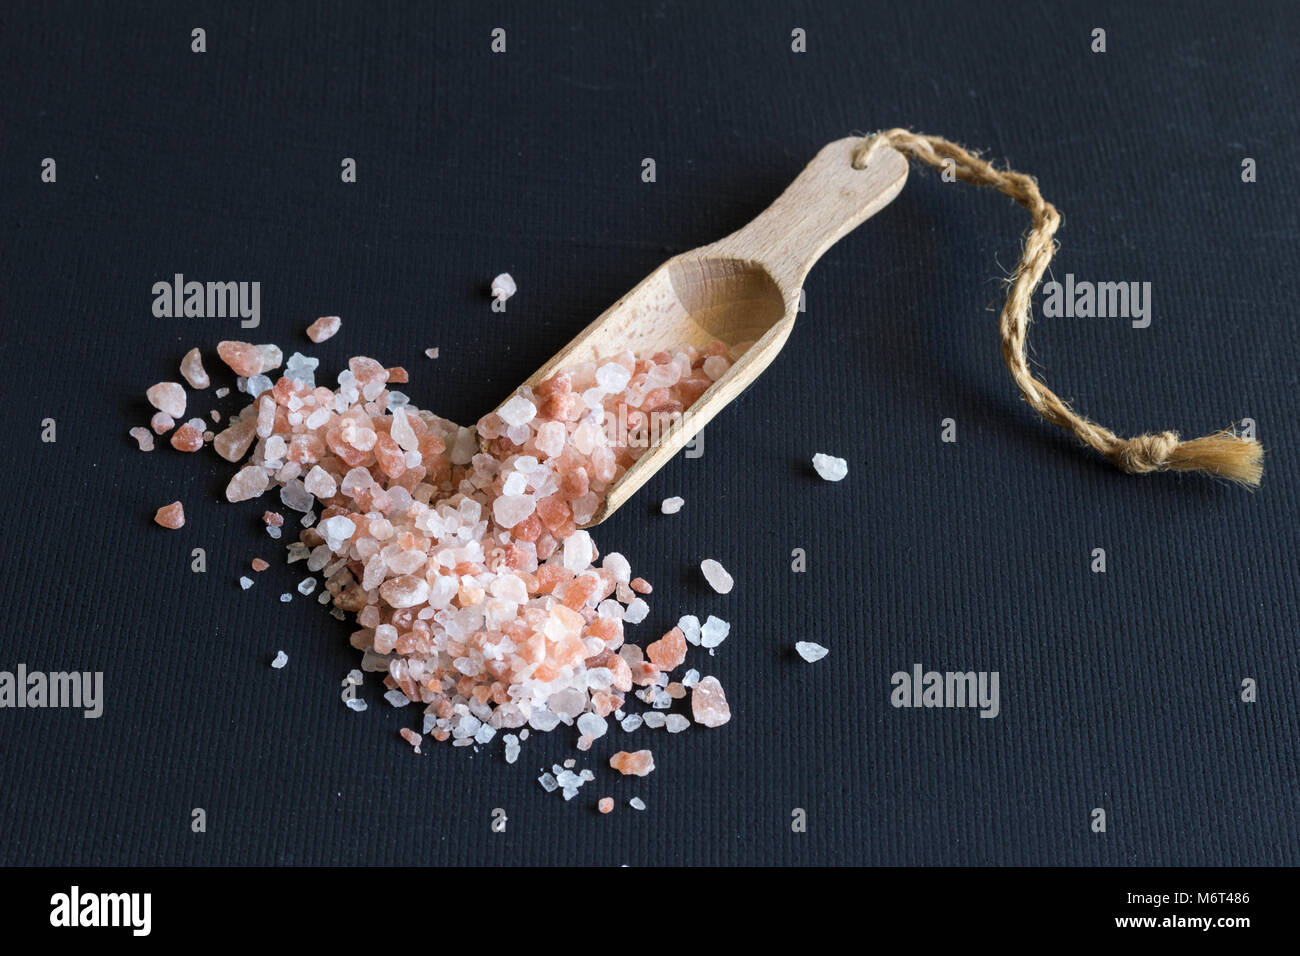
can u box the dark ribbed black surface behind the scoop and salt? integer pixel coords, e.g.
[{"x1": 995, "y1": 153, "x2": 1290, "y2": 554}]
[{"x1": 0, "y1": 3, "x2": 1300, "y2": 865}]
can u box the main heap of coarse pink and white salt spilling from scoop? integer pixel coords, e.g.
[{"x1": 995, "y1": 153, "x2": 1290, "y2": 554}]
[{"x1": 213, "y1": 342, "x2": 736, "y2": 749}]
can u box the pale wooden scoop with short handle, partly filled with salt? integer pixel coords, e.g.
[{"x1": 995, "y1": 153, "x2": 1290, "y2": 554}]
[{"x1": 501, "y1": 138, "x2": 907, "y2": 527}]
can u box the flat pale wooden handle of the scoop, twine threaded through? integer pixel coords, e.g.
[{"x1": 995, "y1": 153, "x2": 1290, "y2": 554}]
[{"x1": 703, "y1": 137, "x2": 907, "y2": 300}]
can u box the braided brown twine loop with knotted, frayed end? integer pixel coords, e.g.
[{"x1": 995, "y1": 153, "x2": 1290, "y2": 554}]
[{"x1": 853, "y1": 129, "x2": 1264, "y2": 488}]
